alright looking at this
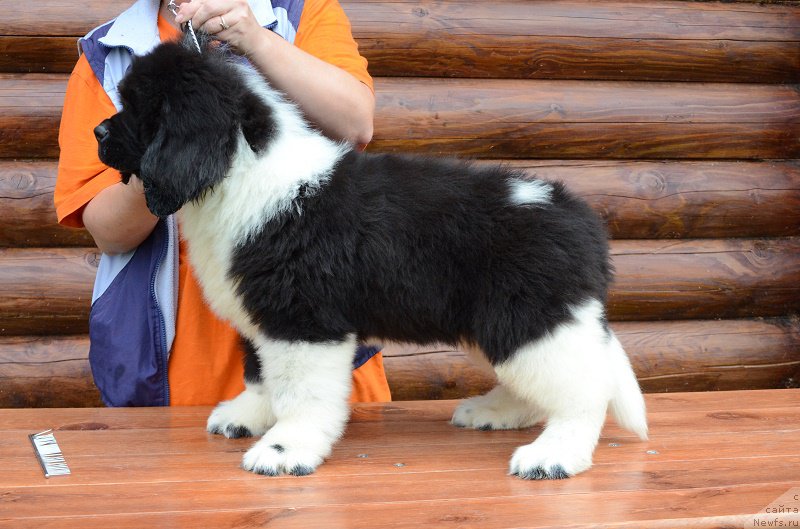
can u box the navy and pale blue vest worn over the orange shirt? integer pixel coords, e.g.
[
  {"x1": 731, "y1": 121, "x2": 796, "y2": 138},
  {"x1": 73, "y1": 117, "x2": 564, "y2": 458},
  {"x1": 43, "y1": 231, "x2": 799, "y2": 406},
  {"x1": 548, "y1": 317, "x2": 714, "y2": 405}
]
[{"x1": 78, "y1": 0, "x2": 377, "y2": 406}]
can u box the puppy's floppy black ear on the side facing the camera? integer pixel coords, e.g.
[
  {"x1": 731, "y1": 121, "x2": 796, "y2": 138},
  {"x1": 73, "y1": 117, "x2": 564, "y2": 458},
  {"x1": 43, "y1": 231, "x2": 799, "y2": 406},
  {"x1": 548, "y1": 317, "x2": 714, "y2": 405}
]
[{"x1": 139, "y1": 100, "x2": 236, "y2": 217}]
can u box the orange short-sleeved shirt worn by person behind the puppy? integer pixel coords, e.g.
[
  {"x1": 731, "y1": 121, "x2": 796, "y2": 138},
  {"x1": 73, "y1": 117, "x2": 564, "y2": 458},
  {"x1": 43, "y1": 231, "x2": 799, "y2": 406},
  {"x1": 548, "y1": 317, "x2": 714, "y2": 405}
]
[{"x1": 54, "y1": 0, "x2": 391, "y2": 405}]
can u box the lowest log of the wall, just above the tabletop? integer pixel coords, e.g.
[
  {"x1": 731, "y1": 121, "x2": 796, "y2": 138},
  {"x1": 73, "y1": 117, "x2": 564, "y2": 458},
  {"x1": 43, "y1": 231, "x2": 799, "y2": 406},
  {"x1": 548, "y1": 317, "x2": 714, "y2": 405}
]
[{"x1": 0, "y1": 320, "x2": 800, "y2": 408}]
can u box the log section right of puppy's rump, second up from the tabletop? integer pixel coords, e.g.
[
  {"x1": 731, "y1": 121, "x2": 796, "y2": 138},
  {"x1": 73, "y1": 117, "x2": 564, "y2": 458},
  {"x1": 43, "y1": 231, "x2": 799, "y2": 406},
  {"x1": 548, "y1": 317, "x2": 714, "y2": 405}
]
[{"x1": 608, "y1": 238, "x2": 800, "y2": 321}]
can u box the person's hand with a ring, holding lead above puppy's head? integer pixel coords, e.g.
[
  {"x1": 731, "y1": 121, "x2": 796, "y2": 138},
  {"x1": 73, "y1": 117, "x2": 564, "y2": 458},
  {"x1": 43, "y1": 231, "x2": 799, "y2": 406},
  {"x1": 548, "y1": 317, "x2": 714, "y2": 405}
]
[{"x1": 175, "y1": 0, "x2": 263, "y2": 55}]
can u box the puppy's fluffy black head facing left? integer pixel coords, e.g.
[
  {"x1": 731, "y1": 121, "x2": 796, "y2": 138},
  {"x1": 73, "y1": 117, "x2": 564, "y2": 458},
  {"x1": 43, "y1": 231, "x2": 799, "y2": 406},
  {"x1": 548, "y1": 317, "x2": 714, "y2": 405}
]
[{"x1": 95, "y1": 34, "x2": 274, "y2": 217}]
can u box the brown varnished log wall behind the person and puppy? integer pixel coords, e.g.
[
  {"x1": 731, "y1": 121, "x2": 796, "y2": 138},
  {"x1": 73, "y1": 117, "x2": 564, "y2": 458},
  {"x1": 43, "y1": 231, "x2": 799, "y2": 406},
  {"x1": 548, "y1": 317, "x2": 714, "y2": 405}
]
[{"x1": 0, "y1": 0, "x2": 800, "y2": 406}]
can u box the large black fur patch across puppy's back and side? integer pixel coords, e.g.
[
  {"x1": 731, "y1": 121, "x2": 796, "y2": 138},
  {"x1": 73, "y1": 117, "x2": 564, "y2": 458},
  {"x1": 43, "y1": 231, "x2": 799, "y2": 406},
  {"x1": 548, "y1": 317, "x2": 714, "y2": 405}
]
[{"x1": 230, "y1": 153, "x2": 611, "y2": 363}]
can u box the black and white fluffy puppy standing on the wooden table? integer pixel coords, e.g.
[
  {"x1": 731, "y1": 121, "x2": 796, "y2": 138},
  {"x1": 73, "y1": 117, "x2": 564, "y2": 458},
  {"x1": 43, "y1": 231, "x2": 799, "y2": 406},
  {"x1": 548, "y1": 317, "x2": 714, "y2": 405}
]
[{"x1": 95, "y1": 38, "x2": 647, "y2": 479}]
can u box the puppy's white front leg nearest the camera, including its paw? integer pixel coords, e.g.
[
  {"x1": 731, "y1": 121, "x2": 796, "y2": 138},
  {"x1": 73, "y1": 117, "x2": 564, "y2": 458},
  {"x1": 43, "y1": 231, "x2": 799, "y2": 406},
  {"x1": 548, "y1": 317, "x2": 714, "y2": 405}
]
[{"x1": 242, "y1": 337, "x2": 356, "y2": 476}]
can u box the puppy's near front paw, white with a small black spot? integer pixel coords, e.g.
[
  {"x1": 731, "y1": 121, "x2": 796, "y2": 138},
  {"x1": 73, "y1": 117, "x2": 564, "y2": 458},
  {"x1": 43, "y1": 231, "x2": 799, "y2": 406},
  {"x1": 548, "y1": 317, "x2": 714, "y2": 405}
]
[{"x1": 242, "y1": 424, "x2": 331, "y2": 476}]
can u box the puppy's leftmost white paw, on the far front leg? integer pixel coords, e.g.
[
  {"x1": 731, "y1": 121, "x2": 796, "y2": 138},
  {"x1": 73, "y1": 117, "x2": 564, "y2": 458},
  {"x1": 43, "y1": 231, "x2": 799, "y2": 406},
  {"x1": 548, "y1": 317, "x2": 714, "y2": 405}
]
[{"x1": 206, "y1": 382, "x2": 275, "y2": 439}]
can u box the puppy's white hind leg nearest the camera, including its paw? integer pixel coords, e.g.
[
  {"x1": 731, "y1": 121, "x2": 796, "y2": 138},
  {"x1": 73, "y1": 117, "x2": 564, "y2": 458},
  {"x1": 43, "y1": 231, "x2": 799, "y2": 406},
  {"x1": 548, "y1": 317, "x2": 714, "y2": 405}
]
[{"x1": 496, "y1": 301, "x2": 614, "y2": 479}]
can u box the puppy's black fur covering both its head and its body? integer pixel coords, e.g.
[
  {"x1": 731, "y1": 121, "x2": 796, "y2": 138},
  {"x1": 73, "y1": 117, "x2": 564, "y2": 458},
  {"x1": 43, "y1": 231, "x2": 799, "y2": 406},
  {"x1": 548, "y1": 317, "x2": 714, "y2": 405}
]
[{"x1": 97, "y1": 39, "x2": 611, "y2": 364}]
